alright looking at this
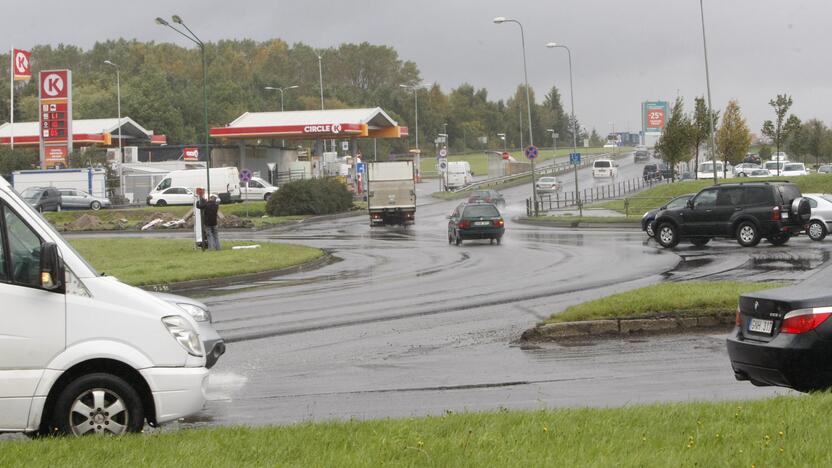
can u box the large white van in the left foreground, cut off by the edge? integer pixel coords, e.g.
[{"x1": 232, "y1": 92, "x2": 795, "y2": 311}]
[{"x1": 0, "y1": 177, "x2": 208, "y2": 435}]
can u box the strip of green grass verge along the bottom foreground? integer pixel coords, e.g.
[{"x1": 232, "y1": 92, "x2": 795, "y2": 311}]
[{"x1": 0, "y1": 394, "x2": 832, "y2": 468}]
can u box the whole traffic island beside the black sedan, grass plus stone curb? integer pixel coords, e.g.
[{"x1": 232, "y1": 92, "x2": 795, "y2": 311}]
[{"x1": 520, "y1": 281, "x2": 787, "y2": 341}]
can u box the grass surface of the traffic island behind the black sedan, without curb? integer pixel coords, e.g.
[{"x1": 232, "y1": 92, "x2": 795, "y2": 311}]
[{"x1": 546, "y1": 281, "x2": 785, "y2": 323}]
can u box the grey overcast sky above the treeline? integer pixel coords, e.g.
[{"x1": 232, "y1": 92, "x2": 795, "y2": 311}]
[{"x1": 0, "y1": 0, "x2": 832, "y2": 137}]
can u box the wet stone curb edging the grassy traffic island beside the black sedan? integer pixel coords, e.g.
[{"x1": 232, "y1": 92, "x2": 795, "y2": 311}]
[{"x1": 520, "y1": 313, "x2": 734, "y2": 341}]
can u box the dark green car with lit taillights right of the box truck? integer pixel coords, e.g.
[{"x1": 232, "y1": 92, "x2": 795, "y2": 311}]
[{"x1": 448, "y1": 203, "x2": 506, "y2": 245}]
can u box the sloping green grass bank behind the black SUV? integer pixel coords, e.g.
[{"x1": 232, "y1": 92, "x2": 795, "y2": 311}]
[{"x1": 591, "y1": 174, "x2": 832, "y2": 217}]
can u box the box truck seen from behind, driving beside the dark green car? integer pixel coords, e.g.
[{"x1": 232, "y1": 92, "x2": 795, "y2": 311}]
[{"x1": 367, "y1": 161, "x2": 416, "y2": 226}]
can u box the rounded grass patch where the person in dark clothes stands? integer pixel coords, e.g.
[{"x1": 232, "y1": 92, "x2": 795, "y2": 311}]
[{"x1": 70, "y1": 239, "x2": 324, "y2": 286}]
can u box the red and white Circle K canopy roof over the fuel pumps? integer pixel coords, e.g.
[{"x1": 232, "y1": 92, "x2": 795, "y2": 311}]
[{"x1": 211, "y1": 107, "x2": 408, "y2": 140}]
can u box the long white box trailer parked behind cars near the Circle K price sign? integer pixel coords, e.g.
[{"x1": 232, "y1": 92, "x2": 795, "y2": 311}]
[{"x1": 11, "y1": 168, "x2": 107, "y2": 198}]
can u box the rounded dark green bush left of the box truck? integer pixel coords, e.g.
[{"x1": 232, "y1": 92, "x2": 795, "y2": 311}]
[{"x1": 266, "y1": 178, "x2": 352, "y2": 216}]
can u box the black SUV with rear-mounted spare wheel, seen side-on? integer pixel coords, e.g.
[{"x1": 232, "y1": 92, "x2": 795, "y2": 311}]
[{"x1": 654, "y1": 182, "x2": 812, "y2": 248}]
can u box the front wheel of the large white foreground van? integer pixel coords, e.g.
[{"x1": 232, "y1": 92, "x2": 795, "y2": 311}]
[{"x1": 51, "y1": 373, "x2": 144, "y2": 436}]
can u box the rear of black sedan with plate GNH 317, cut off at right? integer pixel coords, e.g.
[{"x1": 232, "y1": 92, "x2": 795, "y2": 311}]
[{"x1": 728, "y1": 286, "x2": 832, "y2": 392}]
